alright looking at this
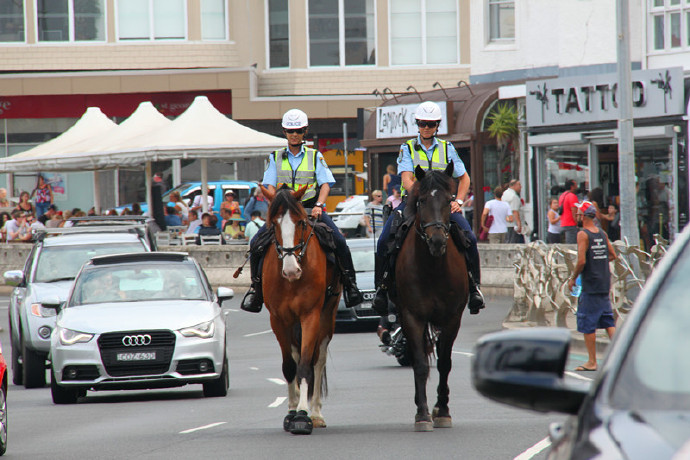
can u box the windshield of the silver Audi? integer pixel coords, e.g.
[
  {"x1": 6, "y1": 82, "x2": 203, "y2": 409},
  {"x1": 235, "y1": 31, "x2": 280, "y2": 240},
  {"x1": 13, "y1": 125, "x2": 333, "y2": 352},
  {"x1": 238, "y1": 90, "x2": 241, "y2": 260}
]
[{"x1": 70, "y1": 263, "x2": 207, "y2": 306}]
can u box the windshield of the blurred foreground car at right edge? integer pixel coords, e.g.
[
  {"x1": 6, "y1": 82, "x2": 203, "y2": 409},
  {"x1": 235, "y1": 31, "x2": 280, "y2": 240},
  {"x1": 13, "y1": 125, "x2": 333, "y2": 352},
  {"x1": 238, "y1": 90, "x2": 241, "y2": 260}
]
[{"x1": 611, "y1": 246, "x2": 690, "y2": 410}]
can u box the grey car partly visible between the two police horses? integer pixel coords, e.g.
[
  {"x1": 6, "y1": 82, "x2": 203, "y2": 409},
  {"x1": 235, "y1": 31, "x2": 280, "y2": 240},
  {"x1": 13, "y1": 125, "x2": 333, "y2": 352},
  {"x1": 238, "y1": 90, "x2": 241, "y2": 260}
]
[{"x1": 335, "y1": 238, "x2": 380, "y2": 325}]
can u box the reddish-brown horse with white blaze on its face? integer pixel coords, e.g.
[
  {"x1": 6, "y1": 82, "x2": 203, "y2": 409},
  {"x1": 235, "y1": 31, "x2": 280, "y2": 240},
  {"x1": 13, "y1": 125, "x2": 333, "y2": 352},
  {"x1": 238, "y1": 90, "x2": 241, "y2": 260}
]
[{"x1": 261, "y1": 187, "x2": 342, "y2": 434}]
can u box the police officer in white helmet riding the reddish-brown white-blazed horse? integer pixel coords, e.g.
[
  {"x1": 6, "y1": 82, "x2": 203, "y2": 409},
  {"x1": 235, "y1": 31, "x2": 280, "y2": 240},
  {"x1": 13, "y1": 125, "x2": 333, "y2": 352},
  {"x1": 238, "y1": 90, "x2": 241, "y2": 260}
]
[{"x1": 241, "y1": 109, "x2": 362, "y2": 313}]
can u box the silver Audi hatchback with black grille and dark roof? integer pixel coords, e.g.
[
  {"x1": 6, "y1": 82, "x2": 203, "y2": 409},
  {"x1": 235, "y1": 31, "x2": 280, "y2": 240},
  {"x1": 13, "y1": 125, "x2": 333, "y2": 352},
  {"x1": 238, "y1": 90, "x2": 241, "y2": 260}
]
[{"x1": 50, "y1": 252, "x2": 233, "y2": 404}]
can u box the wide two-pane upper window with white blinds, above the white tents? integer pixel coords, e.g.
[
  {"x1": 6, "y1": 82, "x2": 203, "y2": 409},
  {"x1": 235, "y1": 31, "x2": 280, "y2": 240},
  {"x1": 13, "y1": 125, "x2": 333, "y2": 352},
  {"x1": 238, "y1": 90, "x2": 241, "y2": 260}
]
[{"x1": 116, "y1": 0, "x2": 187, "y2": 40}]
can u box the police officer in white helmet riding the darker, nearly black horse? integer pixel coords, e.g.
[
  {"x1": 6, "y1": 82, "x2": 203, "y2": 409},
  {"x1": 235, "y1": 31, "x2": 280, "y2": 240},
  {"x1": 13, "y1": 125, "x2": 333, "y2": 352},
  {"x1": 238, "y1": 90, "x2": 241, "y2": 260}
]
[{"x1": 374, "y1": 101, "x2": 485, "y2": 316}]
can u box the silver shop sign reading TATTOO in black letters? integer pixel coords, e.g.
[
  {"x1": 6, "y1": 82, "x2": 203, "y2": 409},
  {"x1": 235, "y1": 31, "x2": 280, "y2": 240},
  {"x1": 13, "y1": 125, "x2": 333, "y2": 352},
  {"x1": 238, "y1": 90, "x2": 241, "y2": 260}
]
[{"x1": 526, "y1": 67, "x2": 684, "y2": 128}]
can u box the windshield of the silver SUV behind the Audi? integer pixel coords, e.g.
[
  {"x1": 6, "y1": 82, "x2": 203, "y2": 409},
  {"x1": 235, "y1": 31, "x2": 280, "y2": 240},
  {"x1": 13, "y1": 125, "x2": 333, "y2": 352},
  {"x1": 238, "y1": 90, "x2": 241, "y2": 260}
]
[{"x1": 34, "y1": 241, "x2": 146, "y2": 283}]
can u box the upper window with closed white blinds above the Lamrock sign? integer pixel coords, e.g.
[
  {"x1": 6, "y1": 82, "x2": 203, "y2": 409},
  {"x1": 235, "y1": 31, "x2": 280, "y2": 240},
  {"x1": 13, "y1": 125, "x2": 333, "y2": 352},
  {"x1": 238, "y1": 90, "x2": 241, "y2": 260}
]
[{"x1": 389, "y1": 0, "x2": 460, "y2": 65}]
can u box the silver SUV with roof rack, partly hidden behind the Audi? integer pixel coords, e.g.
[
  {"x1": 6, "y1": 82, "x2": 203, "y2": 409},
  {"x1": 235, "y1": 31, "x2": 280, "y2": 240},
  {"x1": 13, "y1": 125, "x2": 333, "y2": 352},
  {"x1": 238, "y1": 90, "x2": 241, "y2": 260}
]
[{"x1": 4, "y1": 224, "x2": 151, "y2": 388}]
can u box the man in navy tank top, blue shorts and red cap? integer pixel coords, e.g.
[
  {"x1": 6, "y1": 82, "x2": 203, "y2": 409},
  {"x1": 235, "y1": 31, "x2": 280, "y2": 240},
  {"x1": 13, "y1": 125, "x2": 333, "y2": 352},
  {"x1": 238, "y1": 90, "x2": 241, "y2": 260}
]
[{"x1": 568, "y1": 203, "x2": 616, "y2": 371}]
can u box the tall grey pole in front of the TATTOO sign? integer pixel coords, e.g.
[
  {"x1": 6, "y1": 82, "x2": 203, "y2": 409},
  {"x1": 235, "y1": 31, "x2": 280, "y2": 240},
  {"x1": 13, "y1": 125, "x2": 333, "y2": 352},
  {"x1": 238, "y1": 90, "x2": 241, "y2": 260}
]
[{"x1": 616, "y1": 0, "x2": 640, "y2": 246}]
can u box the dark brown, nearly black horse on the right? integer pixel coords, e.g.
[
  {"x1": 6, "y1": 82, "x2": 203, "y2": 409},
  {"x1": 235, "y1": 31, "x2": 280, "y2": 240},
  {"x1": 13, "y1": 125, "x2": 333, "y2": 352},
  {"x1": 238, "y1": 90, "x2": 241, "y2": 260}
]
[{"x1": 394, "y1": 163, "x2": 469, "y2": 431}]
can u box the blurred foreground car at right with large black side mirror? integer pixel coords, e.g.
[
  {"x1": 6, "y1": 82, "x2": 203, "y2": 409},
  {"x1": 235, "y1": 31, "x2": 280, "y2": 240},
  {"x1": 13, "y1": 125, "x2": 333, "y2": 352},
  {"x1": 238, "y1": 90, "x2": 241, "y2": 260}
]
[{"x1": 472, "y1": 222, "x2": 690, "y2": 459}]
